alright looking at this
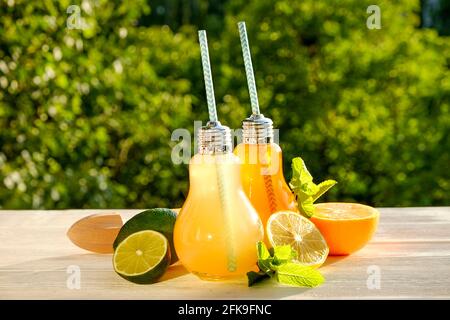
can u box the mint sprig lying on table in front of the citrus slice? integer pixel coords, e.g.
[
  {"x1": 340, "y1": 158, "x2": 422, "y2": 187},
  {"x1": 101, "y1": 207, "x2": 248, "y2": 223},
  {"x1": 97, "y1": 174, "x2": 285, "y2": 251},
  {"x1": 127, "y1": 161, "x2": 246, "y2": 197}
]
[{"x1": 247, "y1": 241, "x2": 325, "y2": 287}]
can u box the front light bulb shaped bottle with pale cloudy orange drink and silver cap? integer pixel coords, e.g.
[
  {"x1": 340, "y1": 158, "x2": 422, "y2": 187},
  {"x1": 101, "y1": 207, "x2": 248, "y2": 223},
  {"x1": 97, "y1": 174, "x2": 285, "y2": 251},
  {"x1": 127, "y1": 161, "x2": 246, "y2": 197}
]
[{"x1": 174, "y1": 122, "x2": 264, "y2": 280}]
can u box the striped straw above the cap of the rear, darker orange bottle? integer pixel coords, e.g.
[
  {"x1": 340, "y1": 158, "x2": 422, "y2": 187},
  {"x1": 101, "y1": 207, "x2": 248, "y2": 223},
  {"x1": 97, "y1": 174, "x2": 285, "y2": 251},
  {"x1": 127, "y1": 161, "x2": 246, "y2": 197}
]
[{"x1": 238, "y1": 21, "x2": 260, "y2": 115}]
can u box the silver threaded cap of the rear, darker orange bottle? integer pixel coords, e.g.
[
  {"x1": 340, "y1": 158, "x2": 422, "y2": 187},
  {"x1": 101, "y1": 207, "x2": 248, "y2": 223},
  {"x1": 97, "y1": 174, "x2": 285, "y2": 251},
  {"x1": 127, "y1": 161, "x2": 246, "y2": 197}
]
[{"x1": 242, "y1": 114, "x2": 273, "y2": 144}]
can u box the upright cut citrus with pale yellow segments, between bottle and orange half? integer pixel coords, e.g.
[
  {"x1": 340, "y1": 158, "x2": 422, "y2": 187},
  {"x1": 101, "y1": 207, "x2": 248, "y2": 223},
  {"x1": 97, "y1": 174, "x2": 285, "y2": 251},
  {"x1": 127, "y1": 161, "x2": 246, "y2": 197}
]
[{"x1": 267, "y1": 211, "x2": 328, "y2": 267}]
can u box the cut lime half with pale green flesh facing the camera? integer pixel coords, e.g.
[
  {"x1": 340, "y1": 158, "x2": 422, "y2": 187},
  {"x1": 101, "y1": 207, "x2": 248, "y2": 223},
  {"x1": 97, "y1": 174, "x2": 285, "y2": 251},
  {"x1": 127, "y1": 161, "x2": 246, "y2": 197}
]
[{"x1": 113, "y1": 230, "x2": 170, "y2": 284}]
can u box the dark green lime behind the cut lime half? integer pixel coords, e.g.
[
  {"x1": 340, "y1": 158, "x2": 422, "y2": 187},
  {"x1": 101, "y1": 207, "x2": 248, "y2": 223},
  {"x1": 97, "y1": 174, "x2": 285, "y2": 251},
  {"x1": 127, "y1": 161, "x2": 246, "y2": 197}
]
[{"x1": 113, "y1": 208, "x2": 178, "y2": 264}]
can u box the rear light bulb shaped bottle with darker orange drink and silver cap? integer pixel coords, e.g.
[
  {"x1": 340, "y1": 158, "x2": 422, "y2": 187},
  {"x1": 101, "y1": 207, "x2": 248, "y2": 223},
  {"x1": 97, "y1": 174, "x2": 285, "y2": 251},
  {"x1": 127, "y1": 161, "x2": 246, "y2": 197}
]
[{"x1": 234, "y1": 114, "x2": 297, "y2": 230}]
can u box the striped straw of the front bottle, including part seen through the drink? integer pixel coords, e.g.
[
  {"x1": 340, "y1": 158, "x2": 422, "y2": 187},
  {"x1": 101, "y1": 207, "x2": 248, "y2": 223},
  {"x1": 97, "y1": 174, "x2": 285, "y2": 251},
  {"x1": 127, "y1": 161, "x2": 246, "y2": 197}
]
[{"x1": 198, "y1": 30, "x2": 237, "y2": 272}]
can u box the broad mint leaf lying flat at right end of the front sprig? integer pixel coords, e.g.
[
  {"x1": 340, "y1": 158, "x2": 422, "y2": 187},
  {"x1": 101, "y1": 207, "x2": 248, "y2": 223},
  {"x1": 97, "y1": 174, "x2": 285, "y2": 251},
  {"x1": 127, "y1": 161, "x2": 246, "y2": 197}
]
[{"x1": 276, "y1": 263, "x2": 325, "y2": 288}]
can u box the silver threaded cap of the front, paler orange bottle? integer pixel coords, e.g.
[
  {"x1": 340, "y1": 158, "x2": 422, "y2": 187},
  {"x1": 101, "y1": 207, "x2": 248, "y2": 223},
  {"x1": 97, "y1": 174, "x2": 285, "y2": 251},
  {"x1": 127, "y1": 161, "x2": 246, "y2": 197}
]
[{"x1": 198, "y1": 121, "x2": 232, "y2": 154}]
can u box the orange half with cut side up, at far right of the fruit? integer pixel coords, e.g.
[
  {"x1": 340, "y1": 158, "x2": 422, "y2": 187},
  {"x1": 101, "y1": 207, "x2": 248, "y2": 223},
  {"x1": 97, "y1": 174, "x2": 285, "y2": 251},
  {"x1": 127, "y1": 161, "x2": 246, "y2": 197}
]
[{"x1": 311, "y1": 202, "x2": 380, "y2": 255}]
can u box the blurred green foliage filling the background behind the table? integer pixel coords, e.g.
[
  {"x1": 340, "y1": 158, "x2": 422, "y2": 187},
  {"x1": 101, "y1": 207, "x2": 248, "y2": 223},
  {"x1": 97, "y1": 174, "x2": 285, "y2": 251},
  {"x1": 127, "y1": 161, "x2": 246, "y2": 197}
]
[{"x1": 0, "y1": 0, "x2": 450, "y2": 209}]
